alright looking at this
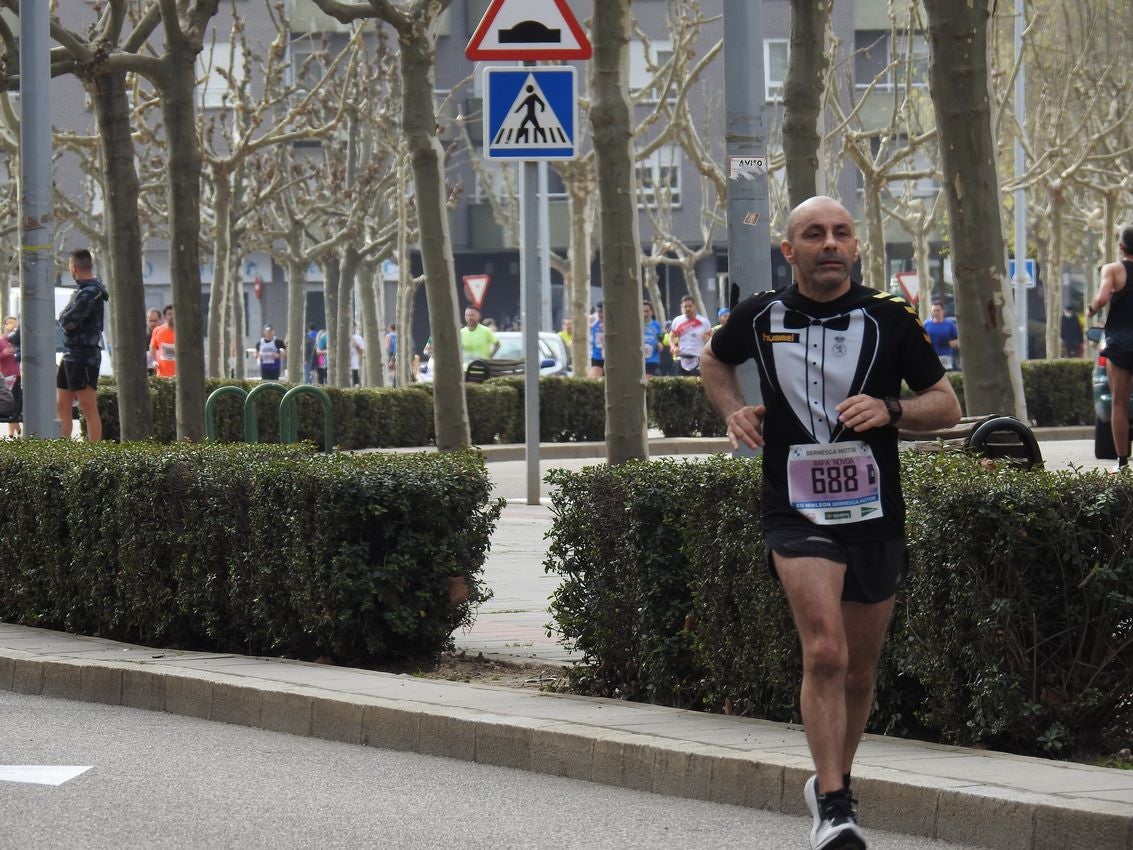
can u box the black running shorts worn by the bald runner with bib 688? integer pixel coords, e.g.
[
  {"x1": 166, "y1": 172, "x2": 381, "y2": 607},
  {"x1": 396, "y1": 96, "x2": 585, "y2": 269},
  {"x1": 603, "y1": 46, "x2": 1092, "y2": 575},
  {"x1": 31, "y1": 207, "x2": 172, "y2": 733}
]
[{"x1": 764, "y1": 518, "x2": 909, "y2": 603}]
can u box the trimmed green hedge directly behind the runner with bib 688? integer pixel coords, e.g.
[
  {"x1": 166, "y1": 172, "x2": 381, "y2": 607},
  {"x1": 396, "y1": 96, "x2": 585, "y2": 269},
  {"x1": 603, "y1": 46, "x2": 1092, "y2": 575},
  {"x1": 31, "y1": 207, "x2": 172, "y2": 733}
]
[{"x1": 546, "y1": 453, "x2": 1133, "y2": 755}]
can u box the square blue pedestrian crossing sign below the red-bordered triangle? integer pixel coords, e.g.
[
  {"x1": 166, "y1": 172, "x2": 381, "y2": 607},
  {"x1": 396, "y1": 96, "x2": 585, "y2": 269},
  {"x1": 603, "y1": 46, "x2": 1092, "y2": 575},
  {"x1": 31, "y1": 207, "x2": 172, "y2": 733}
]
[{"x1": 484, "y1": 66, "x2": 578, "y2": 160}]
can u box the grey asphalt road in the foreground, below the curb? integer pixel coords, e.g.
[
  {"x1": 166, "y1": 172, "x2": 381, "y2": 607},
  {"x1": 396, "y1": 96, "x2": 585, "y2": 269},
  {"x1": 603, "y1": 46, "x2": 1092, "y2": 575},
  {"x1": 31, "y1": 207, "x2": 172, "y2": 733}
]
[{"x1": 0, "y1": 694, "x2": 992, "y2": 850}]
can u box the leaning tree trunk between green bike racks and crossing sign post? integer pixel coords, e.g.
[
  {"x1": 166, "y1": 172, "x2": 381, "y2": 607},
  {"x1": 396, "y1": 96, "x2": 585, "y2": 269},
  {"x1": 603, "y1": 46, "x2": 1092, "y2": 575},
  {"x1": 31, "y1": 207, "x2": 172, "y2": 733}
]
[{"x1": 399, "y1": 28, "x2": 471, "y2": 451}]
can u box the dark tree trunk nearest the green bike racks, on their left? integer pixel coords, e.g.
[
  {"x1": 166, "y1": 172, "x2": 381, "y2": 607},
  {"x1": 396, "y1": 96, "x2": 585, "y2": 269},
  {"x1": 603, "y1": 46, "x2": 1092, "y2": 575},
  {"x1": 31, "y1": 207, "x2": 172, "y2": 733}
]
[{"x1": 161, "y1": 55, "x2": 205, "y2": 441}]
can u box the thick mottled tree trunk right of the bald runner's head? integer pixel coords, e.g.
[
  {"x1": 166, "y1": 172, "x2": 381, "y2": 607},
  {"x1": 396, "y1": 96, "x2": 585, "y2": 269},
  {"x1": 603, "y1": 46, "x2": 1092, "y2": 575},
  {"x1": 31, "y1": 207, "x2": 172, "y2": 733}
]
[{"x1": 925, "y1": 0, "x2": 1026, "y2": 422}]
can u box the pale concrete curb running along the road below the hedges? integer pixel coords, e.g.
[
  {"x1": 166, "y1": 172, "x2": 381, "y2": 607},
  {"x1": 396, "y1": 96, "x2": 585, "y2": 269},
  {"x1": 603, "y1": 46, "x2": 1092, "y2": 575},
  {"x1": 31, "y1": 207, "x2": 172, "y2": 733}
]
[{"x1": 0, "y1": 630, "x2": 1133, "y2": 850}]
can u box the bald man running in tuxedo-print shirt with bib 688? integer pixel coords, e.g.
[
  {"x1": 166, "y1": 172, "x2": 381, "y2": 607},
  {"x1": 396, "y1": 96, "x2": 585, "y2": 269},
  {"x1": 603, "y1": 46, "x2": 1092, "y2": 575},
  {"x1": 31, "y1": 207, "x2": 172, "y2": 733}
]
[{"x1": 700, "y1": 197, "x2": 960, "y2": 850}]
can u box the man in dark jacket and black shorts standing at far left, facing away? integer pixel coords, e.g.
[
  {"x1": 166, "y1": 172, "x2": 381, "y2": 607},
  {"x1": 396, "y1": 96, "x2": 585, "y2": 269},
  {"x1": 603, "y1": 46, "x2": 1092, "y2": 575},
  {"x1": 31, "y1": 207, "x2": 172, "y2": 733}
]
[{"x1": 56, "y1": 248, "x2": 110, "y2": 443}]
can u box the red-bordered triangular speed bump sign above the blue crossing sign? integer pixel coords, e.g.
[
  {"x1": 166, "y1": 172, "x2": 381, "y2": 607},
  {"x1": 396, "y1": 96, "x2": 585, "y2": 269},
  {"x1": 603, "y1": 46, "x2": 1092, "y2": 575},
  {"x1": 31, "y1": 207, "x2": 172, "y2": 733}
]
[{"x1": 465, "y1": 0, "x2": 593, "y2": 61}]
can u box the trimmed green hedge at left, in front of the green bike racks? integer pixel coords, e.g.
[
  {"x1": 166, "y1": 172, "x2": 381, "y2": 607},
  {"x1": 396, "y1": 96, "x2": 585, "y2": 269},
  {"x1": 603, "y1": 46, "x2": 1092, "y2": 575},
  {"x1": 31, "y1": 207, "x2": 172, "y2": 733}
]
[{"x1": 0, "y1": 441, "x2": 502, "y2": 665}]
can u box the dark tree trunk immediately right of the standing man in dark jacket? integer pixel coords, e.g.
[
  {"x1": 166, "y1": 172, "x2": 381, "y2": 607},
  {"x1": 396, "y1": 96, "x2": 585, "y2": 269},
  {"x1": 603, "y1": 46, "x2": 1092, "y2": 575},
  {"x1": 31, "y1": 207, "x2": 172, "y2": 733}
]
[{"x1": 91, "y1": 71, "x2": 153, "y2": 442}]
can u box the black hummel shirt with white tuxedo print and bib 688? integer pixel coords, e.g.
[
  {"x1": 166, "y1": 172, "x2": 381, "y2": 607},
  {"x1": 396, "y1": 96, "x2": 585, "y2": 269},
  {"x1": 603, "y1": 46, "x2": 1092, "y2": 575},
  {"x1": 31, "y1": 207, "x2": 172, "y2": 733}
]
[{"x1": 709, "y1": 283, "x2": 944, "y2": 542}]
